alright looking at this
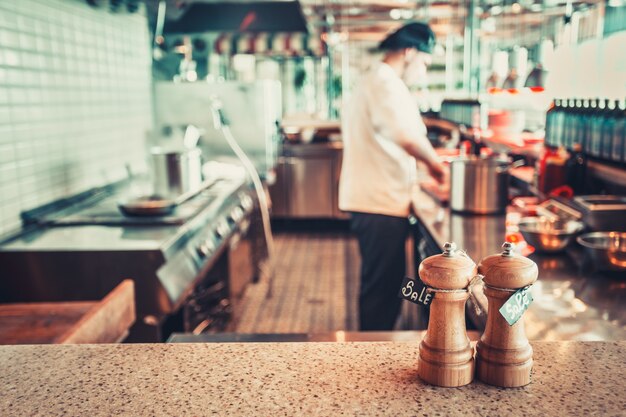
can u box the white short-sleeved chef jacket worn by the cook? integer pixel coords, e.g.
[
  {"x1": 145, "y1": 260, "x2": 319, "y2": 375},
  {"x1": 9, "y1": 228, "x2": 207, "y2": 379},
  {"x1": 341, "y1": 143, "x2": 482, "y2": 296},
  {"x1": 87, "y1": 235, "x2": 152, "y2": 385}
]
[{"x1": 339, "y1": 62, "x2": 437, "y2": 217}]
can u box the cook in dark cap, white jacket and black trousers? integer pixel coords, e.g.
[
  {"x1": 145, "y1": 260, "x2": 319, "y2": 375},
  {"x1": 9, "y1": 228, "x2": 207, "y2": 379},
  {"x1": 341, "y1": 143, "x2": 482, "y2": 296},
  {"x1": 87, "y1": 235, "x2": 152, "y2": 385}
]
[{"x1": 339, "y1": 22, "x2": 447, "y2": 330}]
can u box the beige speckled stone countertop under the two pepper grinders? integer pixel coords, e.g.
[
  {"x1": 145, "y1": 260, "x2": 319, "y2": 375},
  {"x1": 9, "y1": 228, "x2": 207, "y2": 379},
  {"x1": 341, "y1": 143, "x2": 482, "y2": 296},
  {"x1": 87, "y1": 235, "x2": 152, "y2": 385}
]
[{"x1": 0, "y1": 342, "x2": 626, "y2": 417}]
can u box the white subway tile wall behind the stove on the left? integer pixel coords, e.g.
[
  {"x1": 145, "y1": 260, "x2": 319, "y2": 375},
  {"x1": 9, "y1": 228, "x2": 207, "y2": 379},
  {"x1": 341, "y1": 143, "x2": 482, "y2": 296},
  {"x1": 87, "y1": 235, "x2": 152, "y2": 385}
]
[{"x1": 0, "y1": 0, "x2": 152, "y2": 236}]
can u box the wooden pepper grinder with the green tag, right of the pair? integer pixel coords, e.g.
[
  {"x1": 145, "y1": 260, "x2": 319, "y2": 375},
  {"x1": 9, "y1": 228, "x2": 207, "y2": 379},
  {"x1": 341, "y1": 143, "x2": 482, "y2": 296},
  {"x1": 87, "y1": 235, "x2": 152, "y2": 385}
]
[{"x1": 476, "y1": 242, "x2": 538, "y2": 387}]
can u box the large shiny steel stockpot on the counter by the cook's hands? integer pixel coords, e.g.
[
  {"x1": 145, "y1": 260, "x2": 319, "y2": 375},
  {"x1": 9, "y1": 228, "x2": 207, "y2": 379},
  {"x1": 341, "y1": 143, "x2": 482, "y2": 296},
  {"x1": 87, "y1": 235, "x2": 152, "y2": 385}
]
[{"x1": 450, "y1": 157, "x2": 509, "y2": 214}]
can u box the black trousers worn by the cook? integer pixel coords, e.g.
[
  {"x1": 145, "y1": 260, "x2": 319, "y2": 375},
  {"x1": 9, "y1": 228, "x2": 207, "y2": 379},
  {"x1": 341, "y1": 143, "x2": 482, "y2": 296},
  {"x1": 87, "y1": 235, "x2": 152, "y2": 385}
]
[{"x1": 350, "y1": 212, "x2": 409, "y2": 330}]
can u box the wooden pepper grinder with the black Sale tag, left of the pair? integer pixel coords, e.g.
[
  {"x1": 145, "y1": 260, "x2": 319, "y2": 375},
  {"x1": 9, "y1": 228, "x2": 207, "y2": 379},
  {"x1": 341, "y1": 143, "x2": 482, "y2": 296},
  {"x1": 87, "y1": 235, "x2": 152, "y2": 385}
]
[{"x1": 418, "y1": 243, "x2": 476, "y2": 387}]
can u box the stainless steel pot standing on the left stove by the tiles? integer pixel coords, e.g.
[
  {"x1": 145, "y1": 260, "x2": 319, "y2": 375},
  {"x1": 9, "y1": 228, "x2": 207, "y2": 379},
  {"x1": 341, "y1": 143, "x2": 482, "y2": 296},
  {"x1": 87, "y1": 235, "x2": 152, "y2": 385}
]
[{"x1": 150, "y1": 147, "x2": 202, "y2": 198}]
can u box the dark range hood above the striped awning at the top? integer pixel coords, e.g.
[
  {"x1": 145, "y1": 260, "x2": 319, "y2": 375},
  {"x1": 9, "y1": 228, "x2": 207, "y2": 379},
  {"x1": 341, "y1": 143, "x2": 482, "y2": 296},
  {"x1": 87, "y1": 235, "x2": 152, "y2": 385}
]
[{"x1": 164, "y1": 0, "x2": 307, "y2": 34}]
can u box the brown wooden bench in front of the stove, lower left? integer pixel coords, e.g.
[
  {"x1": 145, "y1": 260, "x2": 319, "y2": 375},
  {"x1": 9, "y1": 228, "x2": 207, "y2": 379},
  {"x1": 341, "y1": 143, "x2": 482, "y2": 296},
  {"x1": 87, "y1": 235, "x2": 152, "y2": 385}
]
[{"x1": 0, "y1": 279, "x2": 135, "y2": 345}]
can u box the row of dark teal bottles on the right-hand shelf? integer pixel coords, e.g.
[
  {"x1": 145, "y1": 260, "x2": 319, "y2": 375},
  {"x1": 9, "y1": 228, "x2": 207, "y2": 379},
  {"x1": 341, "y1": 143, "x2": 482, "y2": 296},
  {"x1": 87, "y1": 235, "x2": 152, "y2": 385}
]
[{"x1": 545, "y1": 99, "x2": 626, "y2": 163}]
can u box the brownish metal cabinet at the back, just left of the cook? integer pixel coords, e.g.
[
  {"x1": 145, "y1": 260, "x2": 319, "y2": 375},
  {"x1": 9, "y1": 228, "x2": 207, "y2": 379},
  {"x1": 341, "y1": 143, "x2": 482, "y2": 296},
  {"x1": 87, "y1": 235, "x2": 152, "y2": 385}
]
[{"x1": 270, "y1": 143, "x2": 347, "y2": 219}]
